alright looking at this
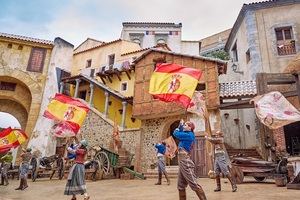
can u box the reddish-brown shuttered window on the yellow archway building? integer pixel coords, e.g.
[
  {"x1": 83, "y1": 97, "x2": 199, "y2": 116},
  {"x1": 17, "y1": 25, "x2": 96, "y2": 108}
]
[{"x1": 27, "y1": 48, "x2": 47, "y2": 72}]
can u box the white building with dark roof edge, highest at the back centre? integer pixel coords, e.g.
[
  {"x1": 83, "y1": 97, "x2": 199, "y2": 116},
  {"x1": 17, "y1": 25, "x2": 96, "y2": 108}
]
[{"x1": 121, "y1": 22, "x2": 200, "y2": 55}]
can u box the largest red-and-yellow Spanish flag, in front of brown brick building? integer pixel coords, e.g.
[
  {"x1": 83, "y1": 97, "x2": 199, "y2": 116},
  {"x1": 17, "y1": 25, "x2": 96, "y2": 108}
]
[{"x1": 149, "y1": 63, "x2": 202, "y2": 108}]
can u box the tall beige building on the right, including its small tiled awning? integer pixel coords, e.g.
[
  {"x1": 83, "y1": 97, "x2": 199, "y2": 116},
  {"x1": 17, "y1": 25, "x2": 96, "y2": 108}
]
[{"x1": 220, "y1": 0, "x2": 300, "y2": 158}]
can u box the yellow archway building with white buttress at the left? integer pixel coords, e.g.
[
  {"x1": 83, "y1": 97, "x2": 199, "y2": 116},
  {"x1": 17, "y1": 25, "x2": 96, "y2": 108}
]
[{"x1": 0, "y1": 33, "x2": 73, "y2": 157}]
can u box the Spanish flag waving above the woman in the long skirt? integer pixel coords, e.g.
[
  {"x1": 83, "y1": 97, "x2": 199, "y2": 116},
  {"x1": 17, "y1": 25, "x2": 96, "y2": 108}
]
[{"x1": 44, "y1": 94, "x2": 89, "y2": 133}]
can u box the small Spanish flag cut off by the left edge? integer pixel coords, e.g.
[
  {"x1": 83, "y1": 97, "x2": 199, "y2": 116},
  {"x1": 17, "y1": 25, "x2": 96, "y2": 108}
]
[{"x1": 0, "y1": 127, "x2": 28, "y2": 153}]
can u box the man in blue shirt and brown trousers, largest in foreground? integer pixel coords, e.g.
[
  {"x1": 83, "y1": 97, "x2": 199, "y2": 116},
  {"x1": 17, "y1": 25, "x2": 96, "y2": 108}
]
[{"x1": 173, "y1": 120, "x2": 206, "y2": 200}]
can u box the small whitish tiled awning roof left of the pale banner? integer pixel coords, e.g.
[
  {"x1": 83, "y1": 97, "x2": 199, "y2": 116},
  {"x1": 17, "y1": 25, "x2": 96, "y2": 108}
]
[{"x1": 219, "y1": 81, "x2": 257, "y2": 98}]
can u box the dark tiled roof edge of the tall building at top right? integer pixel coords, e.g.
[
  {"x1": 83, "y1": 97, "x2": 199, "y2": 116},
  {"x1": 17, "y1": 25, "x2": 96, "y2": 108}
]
[{"x1": 225, "y1": 0, "x2": 300, "y2": 51}]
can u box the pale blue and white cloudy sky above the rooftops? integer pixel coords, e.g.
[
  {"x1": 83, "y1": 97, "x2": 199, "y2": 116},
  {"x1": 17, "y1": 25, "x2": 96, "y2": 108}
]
[{"x1": 0, "y1": 0, "x2": 258, "y2": 47}]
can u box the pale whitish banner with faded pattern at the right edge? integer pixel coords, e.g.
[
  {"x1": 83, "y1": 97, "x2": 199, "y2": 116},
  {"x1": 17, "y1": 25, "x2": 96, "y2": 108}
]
[{"x1": 251, "y1": 92, "x2": 300, "y2": 129}]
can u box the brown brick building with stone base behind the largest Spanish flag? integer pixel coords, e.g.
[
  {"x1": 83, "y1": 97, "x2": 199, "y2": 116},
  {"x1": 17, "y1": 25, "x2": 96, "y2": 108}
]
[{"x1": 133, "y1": 49, "x2": 226, "y2": 173}]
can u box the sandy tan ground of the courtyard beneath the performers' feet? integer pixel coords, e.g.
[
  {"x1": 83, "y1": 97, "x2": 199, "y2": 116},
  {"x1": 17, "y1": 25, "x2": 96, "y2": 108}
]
[{"x1": 0, "y1": 178, "x2": 300, "y2": 200}]
